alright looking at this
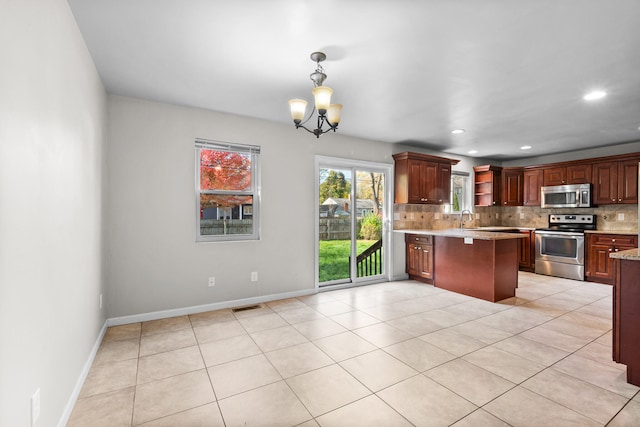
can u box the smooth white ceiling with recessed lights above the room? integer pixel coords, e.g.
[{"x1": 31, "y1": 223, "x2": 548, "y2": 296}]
[{"x1": 68, "y1": 0, "x2": 640, "y2": 159}]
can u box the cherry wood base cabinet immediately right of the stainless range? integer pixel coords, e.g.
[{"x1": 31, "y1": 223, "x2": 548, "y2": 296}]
[{"x1": 585, "y1": 233, "x2": 638, "y2": 285}]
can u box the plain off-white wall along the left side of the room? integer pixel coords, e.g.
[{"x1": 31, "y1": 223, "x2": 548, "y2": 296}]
[{"x1": 0, "y1": 0, "x2": 106, "y2": 427}]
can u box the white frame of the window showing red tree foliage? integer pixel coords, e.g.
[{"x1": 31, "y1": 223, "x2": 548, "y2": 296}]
[{"x1": 195, "y1": 138, "x2": 260, "y2": 242}]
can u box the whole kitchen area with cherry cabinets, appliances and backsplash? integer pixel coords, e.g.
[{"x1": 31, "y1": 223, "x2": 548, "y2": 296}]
[{"x1": 394, "y1": 153, "x2": 640, "y2": 385}]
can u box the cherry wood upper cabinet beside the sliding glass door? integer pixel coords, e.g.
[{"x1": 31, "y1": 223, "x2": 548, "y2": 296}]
[{"x1": 393, "y1": 152, "x2": 459, "y2": 204}]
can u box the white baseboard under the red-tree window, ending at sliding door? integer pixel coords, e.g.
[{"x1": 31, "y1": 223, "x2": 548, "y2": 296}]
[{"x1": 107, "y1": 288, "x2": 317, "y2": 326}]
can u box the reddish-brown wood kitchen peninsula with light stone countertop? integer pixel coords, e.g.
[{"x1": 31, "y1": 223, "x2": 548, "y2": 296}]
[{"x1": 396, "y1": 228, "x2": 523, "y2": 302}]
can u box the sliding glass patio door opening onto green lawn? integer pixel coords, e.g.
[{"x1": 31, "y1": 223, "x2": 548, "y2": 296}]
[{"x1": 316, "y1": 157, "x2": 391, "y2": 287}]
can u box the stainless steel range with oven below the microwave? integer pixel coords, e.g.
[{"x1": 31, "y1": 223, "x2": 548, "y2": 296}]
[{"x1": 535, "y1": 214, "x2": 596, "y2": 280}]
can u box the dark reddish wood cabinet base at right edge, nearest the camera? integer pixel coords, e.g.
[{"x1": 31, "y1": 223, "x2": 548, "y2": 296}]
[{"x1": 613, "y1": 259, "x2": 640, "y2": 386}]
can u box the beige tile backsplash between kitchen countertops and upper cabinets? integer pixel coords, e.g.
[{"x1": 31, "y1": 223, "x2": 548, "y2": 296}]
[{"x1": 393, "y1": 204, "x2": 638, "y2": 232}]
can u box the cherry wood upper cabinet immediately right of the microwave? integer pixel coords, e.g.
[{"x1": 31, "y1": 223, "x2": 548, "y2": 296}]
[{"x1": 592, "y1": 158, "x2": 640, "y2": 205}]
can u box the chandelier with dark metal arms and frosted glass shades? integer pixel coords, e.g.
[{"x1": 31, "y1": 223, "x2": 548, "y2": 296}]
[{"x1": 289, "y1": 52, "x2": 342, "y2": 138}]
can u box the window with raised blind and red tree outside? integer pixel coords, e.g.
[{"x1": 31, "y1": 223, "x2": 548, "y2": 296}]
[{"x1": 195, "y1": 139, "x2": 260, "y2": 242}]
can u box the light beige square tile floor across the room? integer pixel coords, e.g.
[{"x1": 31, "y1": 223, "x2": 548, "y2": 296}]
[{"x1": 68, "y1": 273, "x2": 640, "y2": 427}]
